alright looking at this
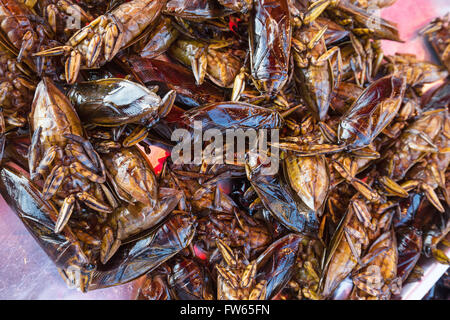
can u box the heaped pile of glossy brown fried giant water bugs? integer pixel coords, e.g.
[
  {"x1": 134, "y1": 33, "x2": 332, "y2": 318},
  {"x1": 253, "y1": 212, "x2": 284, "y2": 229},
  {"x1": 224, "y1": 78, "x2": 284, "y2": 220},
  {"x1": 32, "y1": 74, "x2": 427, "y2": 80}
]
[{"x1": 0, "y1": 0, "x2": 450, "y2": 299}]
